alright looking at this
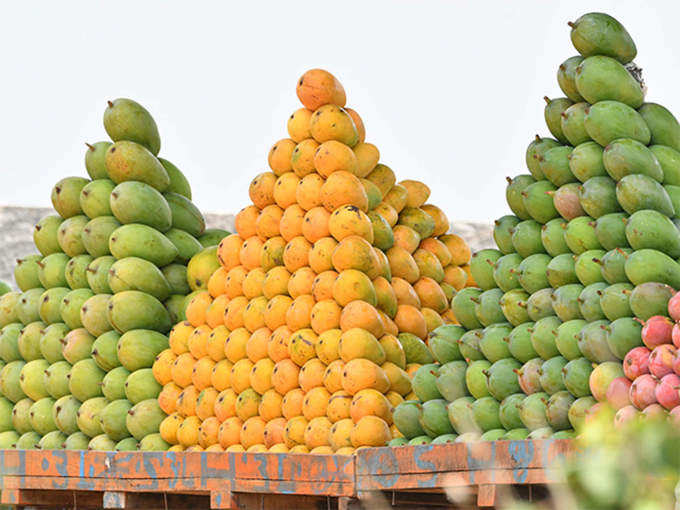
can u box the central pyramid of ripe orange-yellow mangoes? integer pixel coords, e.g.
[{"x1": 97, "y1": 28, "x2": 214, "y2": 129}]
[{"x1": 154, "y1": 70, "x2": 470, "y2": 454}]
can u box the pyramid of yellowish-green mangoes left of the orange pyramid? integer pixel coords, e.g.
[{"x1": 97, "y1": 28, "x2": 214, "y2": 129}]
[{"x1": 0, "y1": 99, "x2": 223, "y2": 450}]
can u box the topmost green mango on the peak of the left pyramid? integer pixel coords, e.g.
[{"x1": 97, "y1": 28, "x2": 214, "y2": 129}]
[{"x1": 104, "y1": 98, "x2": 161, "y2": 156}]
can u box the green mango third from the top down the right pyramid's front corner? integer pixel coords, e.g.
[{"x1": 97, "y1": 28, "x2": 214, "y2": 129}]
[{"x1": 585, "y1": 101, "x2": 652, "y2": 147}]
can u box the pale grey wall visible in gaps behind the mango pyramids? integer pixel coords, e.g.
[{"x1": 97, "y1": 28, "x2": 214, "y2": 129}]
[{"x1": 0, "y1": 206, "x2": 493, "y2": 286}]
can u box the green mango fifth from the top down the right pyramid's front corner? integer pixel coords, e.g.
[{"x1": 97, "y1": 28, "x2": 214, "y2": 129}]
[{"x1": 616, "y1": 174, "x2": 675, "y2": 218}]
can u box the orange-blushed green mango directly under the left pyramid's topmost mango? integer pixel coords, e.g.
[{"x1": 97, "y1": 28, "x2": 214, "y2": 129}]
[{"x1": 106, "y1": 141, "x2": 170, "y2": 192}]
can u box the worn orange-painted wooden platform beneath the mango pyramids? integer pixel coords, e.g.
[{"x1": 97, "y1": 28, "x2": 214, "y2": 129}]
[{"x1": 0, "y1": 439, "x2": 574, "y2": 509}]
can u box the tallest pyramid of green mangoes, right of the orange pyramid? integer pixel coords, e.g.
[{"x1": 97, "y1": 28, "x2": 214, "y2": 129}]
[{"x1": 394, "y1": 13, "x2": 680, "y2": 443}]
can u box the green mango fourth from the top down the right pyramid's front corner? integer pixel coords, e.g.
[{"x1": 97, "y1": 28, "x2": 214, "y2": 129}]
[{"x1": 602, "y1": 138, "x2": 664, "y2": 182}]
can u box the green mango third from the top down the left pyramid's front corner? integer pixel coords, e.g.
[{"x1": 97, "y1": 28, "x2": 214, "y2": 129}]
[{"x1": 110, "y1": 181, "x2": 172, "y2": 232}]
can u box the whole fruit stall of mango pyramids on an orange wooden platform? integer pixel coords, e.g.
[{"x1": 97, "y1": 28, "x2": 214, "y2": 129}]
[{"x1": 0, "y1": 6, "x2": 680, "y2": 508}]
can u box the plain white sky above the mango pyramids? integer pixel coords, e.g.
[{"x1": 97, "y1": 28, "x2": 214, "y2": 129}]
[{"x1": 0, "y1": 0, "x2": 680, "y2": 221}]
